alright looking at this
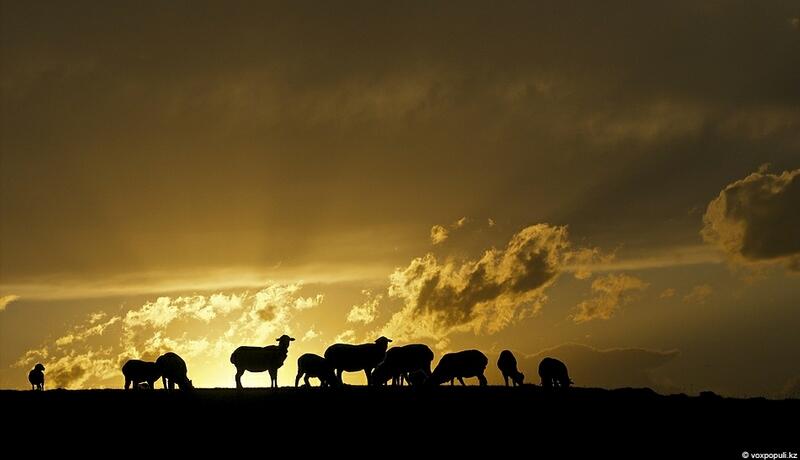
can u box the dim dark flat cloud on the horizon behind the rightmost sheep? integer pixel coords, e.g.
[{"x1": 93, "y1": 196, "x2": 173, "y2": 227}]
[{"x1": 519, "y1": 343, "x2": 679, "y2": 390}]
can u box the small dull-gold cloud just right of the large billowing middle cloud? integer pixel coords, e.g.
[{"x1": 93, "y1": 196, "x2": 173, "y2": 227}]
[{"x1": 572, "y1": 274, "x2": 648, "y2": 323}]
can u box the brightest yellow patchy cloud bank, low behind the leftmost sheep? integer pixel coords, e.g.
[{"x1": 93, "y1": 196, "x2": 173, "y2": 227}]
[{"x1": 15, "y1": 283, "x2": 324, "y2": 388}]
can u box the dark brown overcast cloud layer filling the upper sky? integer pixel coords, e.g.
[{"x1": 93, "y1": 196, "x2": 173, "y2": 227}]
[{"x1": 0, "y1": 1, "x2": 800, "y2": 280}]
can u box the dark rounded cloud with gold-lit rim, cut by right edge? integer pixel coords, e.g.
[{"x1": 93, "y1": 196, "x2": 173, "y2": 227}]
[{"x1": 701, "y1": 169, "x2": 800, "y2": 271}]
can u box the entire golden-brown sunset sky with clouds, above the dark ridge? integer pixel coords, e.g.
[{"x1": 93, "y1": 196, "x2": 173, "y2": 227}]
[{"x1": 0, "y1": 0, "x2": 800, "y2": 397}]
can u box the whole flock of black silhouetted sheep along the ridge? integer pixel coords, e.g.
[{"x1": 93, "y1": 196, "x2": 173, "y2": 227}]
[{"x1": 28, "y1": 335, "x2": 573, "y2": 390}]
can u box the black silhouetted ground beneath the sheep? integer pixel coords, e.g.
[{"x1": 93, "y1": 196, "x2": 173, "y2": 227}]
[{"x1": 0, "y1": 385, "x2": 800, "y2": 458}]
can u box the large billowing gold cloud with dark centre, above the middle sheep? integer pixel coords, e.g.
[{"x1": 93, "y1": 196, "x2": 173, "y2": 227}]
[{"x1": 382, "y1": 224, "x2": 588, "y2": 340}]
